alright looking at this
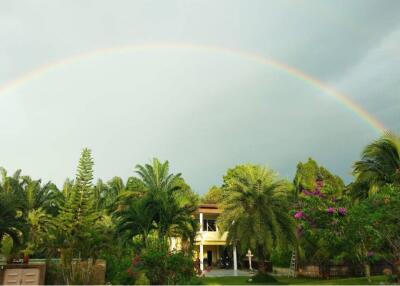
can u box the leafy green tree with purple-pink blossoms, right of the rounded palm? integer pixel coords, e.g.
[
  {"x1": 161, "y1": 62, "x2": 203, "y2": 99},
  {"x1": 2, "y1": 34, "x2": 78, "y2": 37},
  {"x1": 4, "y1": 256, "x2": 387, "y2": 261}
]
[{"x1": 291, "y1": 158, "x2": 349, "y2": 269}]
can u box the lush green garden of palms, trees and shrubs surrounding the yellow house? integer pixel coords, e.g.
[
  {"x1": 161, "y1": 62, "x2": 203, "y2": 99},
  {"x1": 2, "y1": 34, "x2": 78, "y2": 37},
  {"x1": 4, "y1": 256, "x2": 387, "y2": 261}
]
[{"x1": 0, "y1": 133, "x2": 400, "y2": 285}]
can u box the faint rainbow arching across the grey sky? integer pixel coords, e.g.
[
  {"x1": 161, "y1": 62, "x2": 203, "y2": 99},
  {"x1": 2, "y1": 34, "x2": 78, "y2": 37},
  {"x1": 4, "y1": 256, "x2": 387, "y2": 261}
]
[{"x1": 0, "y1": 43, "x2": 386, "y2": 133}]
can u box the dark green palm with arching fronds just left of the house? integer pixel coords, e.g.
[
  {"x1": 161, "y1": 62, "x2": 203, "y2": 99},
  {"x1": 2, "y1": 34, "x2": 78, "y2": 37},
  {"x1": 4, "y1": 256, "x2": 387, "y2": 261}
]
[{"x1": 114, "y1": 159, "x2": 198, "y2": 249}]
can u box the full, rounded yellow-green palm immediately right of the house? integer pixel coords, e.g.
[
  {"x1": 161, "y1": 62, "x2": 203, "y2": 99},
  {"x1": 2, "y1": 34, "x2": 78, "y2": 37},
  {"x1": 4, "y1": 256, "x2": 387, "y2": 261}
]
[{"x1": 217, "y1": 165, "x2": 294, "y2": 272}]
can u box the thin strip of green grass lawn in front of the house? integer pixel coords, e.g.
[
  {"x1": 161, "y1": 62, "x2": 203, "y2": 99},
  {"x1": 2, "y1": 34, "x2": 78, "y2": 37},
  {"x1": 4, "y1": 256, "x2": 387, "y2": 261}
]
[{"x1": 201, "y1": 276, "x2": 386, "y2": 285}]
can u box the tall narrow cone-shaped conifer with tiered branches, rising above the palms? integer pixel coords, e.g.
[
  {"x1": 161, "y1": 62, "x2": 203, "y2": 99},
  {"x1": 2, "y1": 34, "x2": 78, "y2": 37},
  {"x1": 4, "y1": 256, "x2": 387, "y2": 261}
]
[{"x1": 56, "y1": 148, "x2": 101, "y2": 284}]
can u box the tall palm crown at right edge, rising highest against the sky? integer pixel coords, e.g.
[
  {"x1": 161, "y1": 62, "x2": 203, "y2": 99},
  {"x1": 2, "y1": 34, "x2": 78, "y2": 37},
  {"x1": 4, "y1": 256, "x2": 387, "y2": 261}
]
[{"x1": 353, "y1": 132, "x2": 400, "y2": 196}]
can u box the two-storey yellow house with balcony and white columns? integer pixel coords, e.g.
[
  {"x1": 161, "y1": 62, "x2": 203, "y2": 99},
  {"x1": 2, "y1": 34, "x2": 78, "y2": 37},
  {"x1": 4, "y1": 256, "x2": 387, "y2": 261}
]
[{"x1": 195, "y1": 204, "x2": 237, "y2": 271}]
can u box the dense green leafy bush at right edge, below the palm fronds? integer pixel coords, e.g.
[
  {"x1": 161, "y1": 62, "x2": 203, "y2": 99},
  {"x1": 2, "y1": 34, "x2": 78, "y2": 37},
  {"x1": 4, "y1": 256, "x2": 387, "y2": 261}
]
[{"x1": 345, "y1": 185, "x2": 400, "y2": 276}]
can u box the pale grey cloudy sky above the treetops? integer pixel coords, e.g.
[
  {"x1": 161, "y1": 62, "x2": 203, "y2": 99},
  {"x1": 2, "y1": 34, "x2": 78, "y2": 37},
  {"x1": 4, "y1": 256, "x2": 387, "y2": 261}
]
[{"x1": 0, "y1": 0, "x2": 400, "y2": 194}]
